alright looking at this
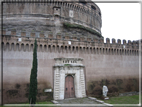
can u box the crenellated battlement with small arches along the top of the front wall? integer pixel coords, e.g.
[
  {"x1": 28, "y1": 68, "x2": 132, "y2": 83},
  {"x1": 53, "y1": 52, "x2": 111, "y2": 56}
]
[{"x1": 3, "y1": 30, "x2": 139, "y2": 55}]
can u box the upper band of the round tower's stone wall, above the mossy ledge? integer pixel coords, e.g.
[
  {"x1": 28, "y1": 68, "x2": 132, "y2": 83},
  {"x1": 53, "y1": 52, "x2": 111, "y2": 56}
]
[{"x1": 2, "y1": 0, "x2": 102, "y2": 33}]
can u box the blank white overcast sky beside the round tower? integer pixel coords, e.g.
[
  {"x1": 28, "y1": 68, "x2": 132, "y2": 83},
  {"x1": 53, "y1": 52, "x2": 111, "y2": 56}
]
[{"x1": 96, "y1": 2, "x2": 141, "y2": 43}]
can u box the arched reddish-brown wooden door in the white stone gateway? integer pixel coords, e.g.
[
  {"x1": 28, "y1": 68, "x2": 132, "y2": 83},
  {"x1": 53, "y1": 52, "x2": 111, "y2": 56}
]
[{"x1": 65, "y1": 75, "x2": 75, "y2": 98}]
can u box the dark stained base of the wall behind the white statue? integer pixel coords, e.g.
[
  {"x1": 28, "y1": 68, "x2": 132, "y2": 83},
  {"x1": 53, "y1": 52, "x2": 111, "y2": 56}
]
[{"x1": 87, "y1": 78, "x2": 139, "y2": 98}]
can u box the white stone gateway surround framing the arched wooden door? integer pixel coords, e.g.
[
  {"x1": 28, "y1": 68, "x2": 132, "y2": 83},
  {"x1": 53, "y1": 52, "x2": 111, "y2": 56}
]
[{"x1": 53, "y1": 58, "x2": 86, "y2": 100}]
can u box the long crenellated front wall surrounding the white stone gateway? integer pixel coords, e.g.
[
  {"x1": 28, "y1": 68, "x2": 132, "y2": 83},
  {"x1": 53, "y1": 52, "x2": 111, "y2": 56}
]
[{"x1": 2, "y1": 29, "x2": 139, "y2": 103}]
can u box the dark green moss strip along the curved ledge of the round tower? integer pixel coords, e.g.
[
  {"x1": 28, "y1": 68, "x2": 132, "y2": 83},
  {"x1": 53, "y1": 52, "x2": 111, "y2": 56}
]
[{"x1": 63, "y1": 22, "x2": 103, "y2": 38}]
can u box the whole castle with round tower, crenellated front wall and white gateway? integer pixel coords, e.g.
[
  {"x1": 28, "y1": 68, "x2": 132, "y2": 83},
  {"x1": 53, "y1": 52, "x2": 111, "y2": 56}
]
[{"x1": 1, "y1": 0, "x2": 141, "y2": 104}]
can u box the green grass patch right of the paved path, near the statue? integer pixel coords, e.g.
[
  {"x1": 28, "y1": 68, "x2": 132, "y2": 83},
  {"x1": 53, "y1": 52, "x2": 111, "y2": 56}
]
[{"x1": 104, "y1": 95, "x2": 139, "y2": 104}]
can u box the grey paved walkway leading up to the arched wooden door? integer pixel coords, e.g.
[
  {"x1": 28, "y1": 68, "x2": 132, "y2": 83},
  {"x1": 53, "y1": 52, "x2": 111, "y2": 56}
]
[{"x1": 56, "y1": 98, "x2": 110, "y2": 107}]
